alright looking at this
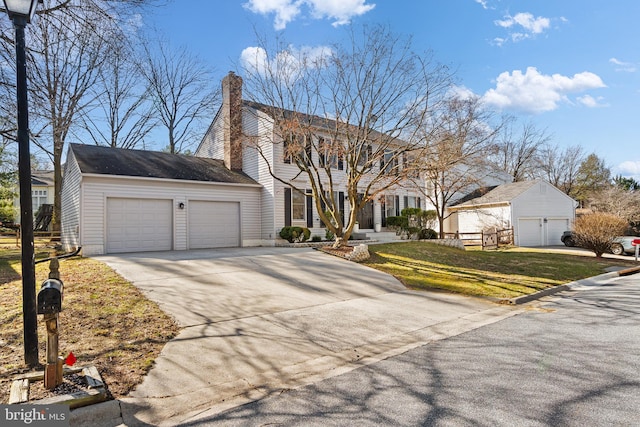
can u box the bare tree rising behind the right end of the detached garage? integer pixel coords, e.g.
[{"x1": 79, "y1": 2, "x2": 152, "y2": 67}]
[{"x1": 538, "y1": 145, "x2": 585, "y2": 195}]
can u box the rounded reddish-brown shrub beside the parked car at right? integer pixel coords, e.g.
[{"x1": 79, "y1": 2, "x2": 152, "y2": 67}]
[{"x1": 573, "y1": 212, "x2": 629, "y2": 258}]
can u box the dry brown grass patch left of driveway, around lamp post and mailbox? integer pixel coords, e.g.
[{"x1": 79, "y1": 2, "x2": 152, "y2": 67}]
[{"x1": 0, "y1": 245, "x2": 178, "y2": 403}]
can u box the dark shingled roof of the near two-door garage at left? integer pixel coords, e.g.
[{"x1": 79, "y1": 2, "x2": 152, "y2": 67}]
[{"x1": 69, "y1": 144, "x2": 259, "y2": 185}]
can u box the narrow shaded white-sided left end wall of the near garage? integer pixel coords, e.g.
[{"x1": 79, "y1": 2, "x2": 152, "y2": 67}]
[{"x1": 60, "y1": 150, "x2": 82, "y2": 251}]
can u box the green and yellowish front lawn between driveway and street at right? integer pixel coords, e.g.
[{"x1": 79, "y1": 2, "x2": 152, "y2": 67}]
[{"x1": 364, "y1": 241, "x2": 637, "y2": 299}]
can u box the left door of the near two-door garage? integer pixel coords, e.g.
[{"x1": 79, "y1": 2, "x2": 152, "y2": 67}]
[{"x1": 107, "y1": 198, "x2": 173, "y2": 253}]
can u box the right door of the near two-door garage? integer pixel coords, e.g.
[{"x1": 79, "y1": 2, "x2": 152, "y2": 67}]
[{"x1": 188, "y1": 200, "x2": 240, "y2": 249}]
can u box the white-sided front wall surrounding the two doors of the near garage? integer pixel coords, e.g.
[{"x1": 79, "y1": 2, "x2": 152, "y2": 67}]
[{"x1": 63, "y1": 175, "x2": 262, "y2": 255}]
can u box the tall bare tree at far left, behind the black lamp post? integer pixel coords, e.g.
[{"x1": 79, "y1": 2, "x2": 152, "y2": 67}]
[{"x1": 0, "y1": 0, "x2": 162, "y2": 234}]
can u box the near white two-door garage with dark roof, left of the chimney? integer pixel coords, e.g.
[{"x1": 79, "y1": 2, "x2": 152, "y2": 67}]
[{"x1": 62, "y1": 144, "x2": 262, "y2": 255}]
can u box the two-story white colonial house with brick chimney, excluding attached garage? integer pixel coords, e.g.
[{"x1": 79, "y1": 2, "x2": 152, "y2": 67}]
[{"x1": 195, "y1": 73, "x2": 424, "y2": 244}]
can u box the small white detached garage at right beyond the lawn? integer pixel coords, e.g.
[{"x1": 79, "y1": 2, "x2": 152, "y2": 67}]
[{"x1": 449, "y1": 180, "x2": 577, "y2": 246}]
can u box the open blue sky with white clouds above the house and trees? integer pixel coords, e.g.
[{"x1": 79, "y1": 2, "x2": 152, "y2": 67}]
[{"x1": 144, "y1": 0, "x2": 640, "y2": 181}]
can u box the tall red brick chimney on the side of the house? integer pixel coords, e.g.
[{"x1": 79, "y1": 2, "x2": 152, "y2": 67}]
[{"x1": 222, "y1": 71, "x2": 242, "y2": 170}]
